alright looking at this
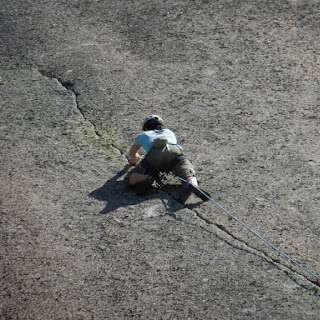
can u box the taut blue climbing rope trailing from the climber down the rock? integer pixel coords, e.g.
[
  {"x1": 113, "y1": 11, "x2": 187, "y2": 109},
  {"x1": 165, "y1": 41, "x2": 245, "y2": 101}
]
[{"x1": 171, "y1": 173, "x2": 320, "y2": 286}]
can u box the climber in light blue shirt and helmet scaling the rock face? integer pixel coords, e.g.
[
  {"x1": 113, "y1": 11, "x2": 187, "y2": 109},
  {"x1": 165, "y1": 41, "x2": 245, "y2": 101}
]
[{"x1": 125, "y1": 115, "x2": 205, "y2": 203}]
